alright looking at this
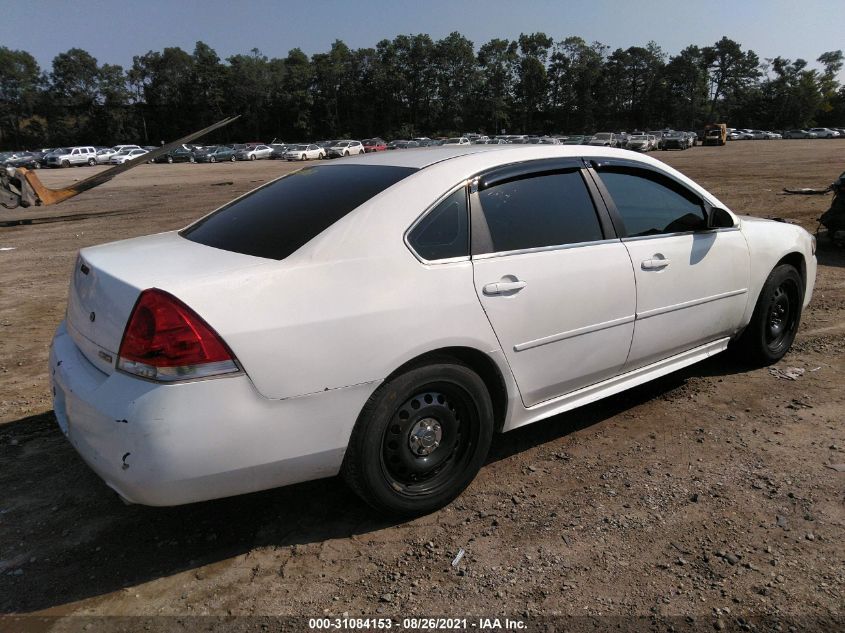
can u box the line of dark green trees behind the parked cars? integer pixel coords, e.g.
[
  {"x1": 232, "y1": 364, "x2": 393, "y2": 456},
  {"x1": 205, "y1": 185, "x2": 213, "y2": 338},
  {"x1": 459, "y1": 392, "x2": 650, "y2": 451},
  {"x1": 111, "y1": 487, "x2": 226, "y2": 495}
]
[{"x1": 0, "y1": 32, "x2": 845, "y2": 149}]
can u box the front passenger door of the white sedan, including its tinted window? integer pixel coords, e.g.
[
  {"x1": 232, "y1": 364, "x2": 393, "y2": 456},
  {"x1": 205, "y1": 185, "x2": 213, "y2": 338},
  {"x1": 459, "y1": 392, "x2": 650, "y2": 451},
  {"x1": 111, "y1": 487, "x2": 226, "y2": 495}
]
[{"x1": 597, "y1": 162, "x2": 749, "y2": 371}]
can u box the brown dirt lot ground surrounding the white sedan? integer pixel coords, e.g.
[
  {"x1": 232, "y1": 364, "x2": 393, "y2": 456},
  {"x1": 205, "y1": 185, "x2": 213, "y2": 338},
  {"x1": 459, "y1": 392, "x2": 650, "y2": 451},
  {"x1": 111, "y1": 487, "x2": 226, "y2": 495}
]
[{"x1": 0, "y1": 141, "x2": 845, "y2": 631}]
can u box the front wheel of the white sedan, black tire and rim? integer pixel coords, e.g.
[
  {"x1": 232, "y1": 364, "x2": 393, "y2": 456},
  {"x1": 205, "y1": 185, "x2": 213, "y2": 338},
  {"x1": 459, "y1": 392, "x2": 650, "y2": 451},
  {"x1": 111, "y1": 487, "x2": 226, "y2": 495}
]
[{"x1": 734, "y1": 264, "x2": 804, "y2": 366}]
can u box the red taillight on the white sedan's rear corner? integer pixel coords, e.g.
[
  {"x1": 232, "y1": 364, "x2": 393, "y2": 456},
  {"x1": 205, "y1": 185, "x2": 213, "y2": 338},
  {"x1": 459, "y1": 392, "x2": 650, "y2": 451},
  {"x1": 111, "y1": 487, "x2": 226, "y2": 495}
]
[{"x1": 117, "y1": 288, "x2": 238, "y2": 381}]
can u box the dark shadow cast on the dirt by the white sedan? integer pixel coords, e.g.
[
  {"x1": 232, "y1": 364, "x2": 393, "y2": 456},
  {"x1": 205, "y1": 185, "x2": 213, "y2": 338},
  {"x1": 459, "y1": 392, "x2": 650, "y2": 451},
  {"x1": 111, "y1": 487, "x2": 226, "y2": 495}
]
[{"x1": 0, "y1": 355, "x2": 744, "y2": 614}]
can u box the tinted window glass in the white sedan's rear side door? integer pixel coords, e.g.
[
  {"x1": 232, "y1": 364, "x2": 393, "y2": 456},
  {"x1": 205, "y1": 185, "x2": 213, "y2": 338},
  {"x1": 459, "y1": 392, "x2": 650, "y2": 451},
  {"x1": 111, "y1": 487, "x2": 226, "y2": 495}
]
[{"x1": 479, "y1": 171, "x2": 603, "y2": 252}]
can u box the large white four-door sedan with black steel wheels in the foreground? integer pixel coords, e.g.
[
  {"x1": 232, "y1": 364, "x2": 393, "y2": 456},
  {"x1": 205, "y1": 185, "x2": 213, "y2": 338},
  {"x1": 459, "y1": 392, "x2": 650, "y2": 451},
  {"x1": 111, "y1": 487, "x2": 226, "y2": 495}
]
[{"x1": 49, "y1": 145, "x2": 816, "y2": 515}]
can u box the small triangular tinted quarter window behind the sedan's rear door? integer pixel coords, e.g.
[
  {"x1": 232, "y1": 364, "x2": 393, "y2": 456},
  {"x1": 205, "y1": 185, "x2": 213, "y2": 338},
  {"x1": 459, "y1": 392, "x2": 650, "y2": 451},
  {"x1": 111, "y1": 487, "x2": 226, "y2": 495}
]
[{"x1": 408, "y1": 187, "x2": 469, "y2": 261}]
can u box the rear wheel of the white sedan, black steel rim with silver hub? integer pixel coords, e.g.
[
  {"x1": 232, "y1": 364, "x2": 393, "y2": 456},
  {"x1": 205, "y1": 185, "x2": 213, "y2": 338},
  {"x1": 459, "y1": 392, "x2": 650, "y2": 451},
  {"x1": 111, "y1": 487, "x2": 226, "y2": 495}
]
[{"x1": 342, "y1": 362, "x2": 493, "y2": 516}]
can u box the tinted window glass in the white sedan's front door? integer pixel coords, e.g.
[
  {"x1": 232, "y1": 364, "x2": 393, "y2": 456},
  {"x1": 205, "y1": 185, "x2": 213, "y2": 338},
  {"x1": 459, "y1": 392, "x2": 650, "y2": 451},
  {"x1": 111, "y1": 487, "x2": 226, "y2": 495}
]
[{"x1": 600, "y1": 168, "x2": 707, "y2": 237}]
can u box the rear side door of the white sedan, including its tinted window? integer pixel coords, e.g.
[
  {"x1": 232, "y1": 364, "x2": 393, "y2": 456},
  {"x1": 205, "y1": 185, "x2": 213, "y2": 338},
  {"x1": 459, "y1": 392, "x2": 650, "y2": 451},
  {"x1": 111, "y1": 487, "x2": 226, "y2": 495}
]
[{"x1": 470, "y1": 159, "x2": 636, "y2": 407}]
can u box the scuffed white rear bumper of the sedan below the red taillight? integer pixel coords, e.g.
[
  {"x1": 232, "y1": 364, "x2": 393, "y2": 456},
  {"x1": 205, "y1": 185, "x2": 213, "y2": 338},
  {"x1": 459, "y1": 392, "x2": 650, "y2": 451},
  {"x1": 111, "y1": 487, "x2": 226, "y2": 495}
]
[{"x1": 50, "y1": 323, "x2": 377, "y2": 506}]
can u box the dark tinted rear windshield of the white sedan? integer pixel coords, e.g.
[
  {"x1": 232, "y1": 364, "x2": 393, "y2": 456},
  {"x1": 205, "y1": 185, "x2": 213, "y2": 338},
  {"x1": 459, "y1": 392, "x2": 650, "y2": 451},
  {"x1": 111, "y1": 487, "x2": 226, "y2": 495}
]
[{"x1": 181, "y1": 165, "x2": 416, "y2": 259}]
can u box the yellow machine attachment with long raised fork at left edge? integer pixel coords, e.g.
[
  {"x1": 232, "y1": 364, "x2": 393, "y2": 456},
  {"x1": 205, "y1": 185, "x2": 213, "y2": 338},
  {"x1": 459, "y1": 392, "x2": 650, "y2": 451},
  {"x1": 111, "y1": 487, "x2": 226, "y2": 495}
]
[{"x1": 0, "y1": 115, "x2": 240, "y2": 209}]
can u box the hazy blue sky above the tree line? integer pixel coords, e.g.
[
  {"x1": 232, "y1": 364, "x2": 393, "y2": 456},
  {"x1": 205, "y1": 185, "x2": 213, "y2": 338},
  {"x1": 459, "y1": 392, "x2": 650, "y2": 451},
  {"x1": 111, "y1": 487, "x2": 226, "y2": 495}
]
[{"x1": 0, "y1": 0, "x2": 845, "y2": 81}]
